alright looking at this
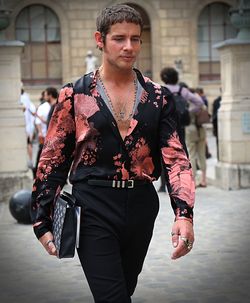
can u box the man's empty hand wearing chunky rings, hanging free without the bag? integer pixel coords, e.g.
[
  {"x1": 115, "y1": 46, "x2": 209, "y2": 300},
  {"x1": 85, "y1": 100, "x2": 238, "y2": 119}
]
[{"x1": 171, "y1": 219, "x2": 194, "y2": 260}]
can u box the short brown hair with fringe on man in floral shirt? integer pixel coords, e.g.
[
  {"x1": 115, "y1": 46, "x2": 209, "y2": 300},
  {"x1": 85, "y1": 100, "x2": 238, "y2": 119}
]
[{"x1": 96, "y1": 4, "x2": 143, "y2": 44}]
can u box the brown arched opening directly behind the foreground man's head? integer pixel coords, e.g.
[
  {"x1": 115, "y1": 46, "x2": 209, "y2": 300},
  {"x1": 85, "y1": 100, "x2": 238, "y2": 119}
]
[{"x1": 126, "y1": 3, "x2": 152, "y2": 78}]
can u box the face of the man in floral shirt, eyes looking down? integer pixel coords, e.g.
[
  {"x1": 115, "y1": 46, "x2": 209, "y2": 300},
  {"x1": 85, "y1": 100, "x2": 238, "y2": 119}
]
[{"x1": 103, "y1": 22, "x2": 141, "y2": 69}]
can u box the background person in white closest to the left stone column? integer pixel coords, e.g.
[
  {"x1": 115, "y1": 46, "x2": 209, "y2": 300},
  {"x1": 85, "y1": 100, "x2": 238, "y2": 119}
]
[{"x1": 19, "y1": 89, "x2": 36, "y2": 169}]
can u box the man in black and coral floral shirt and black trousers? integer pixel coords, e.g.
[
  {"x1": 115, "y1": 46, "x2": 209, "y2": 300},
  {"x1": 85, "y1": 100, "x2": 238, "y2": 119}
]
[{"x1": 32, "y1": 5, "x2": 194, "y2": 303}]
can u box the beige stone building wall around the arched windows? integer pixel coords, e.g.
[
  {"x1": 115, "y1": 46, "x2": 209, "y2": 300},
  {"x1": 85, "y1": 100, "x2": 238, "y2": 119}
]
[{"x1": 7, "y1": 0, "x2": 237, "y2": 107}]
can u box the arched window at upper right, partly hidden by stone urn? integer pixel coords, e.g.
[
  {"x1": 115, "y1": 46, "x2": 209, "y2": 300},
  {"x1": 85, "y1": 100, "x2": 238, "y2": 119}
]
[{"x1": 198, "y1": 2, "x2": 237, "y2": 81}]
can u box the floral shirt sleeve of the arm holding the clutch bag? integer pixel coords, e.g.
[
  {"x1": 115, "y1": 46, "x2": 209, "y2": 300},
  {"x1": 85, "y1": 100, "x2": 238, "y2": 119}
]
[{"x1": 31, "y1": 84, "x2": 75, "y2": 239}]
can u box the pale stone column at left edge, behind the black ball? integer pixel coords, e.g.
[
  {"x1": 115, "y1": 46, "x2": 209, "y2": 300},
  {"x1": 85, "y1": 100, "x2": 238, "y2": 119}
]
[{"x1": 0, "y1": 40, "x2": 31, "y2": 201}]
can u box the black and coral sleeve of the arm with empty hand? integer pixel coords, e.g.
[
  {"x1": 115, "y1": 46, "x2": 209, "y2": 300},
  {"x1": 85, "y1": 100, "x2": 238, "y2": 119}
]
[{"x1": 160, "y1": 89, "x2": 195, "y2": 223}]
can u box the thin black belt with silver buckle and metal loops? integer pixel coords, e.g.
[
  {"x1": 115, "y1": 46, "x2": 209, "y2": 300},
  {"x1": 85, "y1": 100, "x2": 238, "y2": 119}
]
[{"x1": 88, "y1": 179, "x2": 151, "y2": 188}]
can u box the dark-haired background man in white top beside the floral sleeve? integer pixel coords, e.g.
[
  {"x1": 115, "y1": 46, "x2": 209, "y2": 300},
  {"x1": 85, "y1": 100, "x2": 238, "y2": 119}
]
[{"x1": 33, "y1": 87, "x2": 58, "y2": 177}]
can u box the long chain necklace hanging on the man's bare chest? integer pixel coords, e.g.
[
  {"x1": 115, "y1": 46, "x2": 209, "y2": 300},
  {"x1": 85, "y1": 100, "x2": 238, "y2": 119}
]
[{"x1": 98, "y1": 68, "x2": 137, "y2": 122}]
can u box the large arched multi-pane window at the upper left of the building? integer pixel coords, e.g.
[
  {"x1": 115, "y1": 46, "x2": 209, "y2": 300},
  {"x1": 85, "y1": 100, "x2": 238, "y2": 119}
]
[{"x1": 15, "y1": 5, "x2": 62, "y2": 85}]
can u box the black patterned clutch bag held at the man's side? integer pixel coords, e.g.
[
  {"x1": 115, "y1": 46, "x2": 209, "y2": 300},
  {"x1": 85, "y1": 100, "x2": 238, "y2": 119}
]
[{"x1": 52, "y1": 191, "x2": 81, "y2": 259}]
